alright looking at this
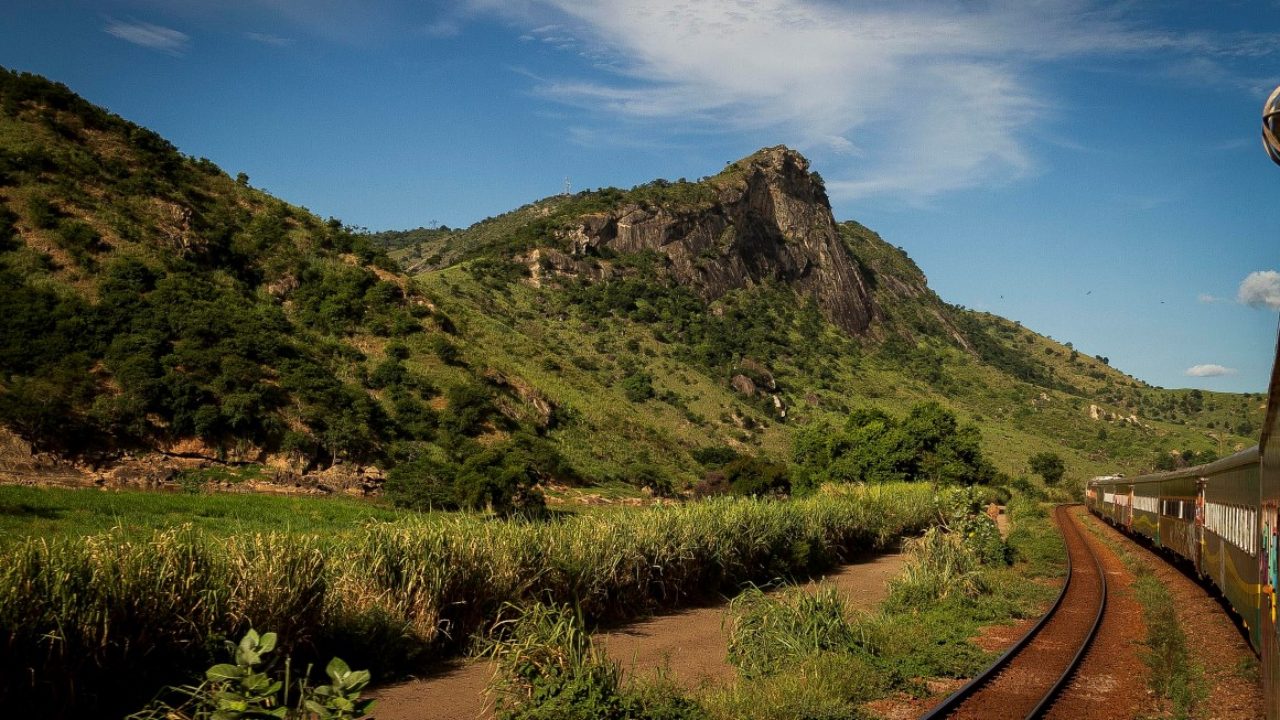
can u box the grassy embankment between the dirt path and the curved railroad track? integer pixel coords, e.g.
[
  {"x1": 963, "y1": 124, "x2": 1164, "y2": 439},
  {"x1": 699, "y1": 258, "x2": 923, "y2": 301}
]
[{"x1": 490, "y1": 489, "x2": 1065, "y2": 720}]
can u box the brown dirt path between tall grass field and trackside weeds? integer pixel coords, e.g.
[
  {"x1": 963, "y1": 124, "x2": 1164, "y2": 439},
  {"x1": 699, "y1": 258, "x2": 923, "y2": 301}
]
[{"x1": 371, "y1": 553, "x2": 904, "y2": 720}]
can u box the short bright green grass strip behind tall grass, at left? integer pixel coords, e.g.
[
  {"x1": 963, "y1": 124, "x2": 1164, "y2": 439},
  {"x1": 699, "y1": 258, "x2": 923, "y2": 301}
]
[{"x1": 0, "y1": 486, "x2": 413, "y2": 542}]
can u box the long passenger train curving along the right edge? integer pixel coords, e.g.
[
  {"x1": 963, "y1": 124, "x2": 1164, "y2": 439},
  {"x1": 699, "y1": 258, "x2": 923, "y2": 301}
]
[{"x1": 1084, "y1": 322, "x2": 1280, "y2": 720}]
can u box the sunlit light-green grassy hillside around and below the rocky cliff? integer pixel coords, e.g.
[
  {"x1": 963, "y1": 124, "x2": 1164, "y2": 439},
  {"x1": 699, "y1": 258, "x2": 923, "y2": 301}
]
[{"x1": 374, "y1": 169, "x2": 1262, "y2": 480}]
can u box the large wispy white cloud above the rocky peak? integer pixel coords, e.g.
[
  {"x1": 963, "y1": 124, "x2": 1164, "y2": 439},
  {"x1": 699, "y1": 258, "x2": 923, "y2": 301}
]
[{"x1": 468, "y1": 0, "x2": 1275, "y2": 200}]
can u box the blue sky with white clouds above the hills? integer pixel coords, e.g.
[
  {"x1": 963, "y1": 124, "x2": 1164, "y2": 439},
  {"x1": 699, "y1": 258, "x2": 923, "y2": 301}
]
[{"x1": 0, "y1": 0, "x2": 1280, "y2": 392}]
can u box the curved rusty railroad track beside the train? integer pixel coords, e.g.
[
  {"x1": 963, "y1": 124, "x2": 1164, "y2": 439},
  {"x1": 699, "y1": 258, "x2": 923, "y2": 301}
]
[{"x1": 920, "y1": 505, "x2": 1107, "y2": 720}]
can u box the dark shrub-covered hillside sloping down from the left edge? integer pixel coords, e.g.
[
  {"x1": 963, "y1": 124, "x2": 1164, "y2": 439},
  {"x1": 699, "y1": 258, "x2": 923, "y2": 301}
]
[{"x1": 0, "y1": 72, "x2": 581, "y2": 502}]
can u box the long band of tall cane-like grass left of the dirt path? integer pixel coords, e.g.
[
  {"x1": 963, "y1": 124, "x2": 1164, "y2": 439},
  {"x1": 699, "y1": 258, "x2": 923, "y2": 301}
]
[{"x1": 0, "y1": 486, "x2": 937, "y2": 717}]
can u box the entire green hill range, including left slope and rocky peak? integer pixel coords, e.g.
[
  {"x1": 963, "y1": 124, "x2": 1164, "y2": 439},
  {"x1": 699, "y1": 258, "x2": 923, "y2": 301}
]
[{"x1": 0, "y1": 72, "x2": 1262, "y2": 505}]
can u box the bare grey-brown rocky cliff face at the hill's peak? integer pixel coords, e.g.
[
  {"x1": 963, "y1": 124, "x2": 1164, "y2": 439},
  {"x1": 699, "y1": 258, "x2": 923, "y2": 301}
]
[{"x1": 560, "y1": 146, "x2": 878, "y2": 334}]
